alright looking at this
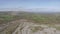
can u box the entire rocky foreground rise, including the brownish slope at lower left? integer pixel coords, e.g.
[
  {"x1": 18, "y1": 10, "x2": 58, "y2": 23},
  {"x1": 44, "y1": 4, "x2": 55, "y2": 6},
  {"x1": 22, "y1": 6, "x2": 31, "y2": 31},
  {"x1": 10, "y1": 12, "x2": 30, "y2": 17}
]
[{"x1": 0, "y1": 19, "x2": 60, "y2": 34}]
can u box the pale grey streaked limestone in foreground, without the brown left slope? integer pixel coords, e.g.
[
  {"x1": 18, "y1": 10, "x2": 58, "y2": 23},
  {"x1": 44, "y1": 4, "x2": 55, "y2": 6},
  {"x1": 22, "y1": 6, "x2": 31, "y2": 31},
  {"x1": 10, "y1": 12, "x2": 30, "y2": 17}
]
[{"x1": 12, "y1": 20, "x2": 60, "y2": 34}]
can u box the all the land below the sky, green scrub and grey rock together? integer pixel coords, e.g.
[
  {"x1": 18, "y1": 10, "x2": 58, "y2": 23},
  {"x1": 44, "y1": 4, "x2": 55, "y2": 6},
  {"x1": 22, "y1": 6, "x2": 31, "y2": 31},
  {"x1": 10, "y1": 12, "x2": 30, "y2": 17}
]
[{"x1": 0, "y1": 11, "x2": 60, "y2": 34}]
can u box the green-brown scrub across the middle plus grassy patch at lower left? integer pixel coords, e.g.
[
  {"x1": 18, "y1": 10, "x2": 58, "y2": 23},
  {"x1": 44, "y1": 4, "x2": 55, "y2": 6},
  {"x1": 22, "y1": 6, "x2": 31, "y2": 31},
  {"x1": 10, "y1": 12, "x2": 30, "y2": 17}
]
[{"x1": 0, "y1": 12, "x2": 60, "y2": 34}]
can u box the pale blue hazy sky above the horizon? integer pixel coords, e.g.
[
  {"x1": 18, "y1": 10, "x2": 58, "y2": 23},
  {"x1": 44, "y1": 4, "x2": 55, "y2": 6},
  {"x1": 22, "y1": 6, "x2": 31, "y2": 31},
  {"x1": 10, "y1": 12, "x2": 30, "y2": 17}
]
[{"x1": 0, "y1": 0, "x2": 60, "y2": 11}]
